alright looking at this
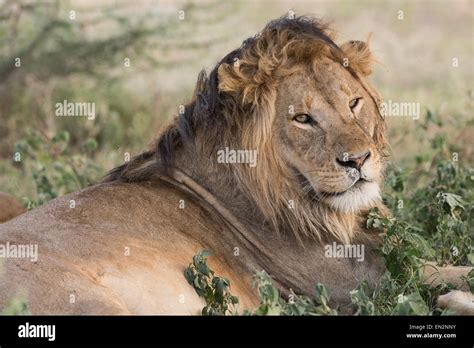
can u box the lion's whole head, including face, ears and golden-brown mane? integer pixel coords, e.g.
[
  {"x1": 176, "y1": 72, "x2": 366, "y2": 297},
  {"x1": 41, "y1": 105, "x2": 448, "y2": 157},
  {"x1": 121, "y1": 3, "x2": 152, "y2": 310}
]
[{"x1": 108, "y1": 17, "x2": 385, "y2": 242}]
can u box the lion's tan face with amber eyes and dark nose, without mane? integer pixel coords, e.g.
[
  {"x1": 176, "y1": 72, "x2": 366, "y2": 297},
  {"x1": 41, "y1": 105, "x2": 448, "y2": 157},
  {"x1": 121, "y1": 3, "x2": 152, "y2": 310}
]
[{"x1": 274, "y1": 58, "x2": 383, "y2": 212}]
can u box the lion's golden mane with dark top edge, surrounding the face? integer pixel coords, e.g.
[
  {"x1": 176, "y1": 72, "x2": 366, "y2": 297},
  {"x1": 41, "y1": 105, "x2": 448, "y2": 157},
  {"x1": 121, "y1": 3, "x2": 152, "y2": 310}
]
[{"x1": 105, "y1": 17, "x2": 385, "y2": 243}]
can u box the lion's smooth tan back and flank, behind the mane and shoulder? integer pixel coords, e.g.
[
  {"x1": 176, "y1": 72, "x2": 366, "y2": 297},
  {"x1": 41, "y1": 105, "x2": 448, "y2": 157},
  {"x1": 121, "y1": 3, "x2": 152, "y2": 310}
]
[{"x1": 0, "y1": 183, "x2": 217, "y2": 314}]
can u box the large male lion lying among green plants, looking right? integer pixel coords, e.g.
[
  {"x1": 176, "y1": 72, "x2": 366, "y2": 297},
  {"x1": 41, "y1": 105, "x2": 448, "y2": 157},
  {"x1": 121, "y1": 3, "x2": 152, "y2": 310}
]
[{"x1": 0, "y1": 17, "x2": 470, "y2": 314}]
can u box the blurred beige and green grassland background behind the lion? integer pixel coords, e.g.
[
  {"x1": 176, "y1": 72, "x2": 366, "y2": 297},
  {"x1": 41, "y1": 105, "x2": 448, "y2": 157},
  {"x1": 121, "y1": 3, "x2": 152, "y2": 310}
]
[{"x1": 0, "y1": 0, "x2": 474, "y2": 204}]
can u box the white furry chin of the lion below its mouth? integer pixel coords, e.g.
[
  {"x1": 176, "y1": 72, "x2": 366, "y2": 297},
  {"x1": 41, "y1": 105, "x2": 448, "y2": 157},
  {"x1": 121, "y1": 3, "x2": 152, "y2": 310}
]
[{"x1": 325, "y1": 182, "x2": 381, "y2": 213}]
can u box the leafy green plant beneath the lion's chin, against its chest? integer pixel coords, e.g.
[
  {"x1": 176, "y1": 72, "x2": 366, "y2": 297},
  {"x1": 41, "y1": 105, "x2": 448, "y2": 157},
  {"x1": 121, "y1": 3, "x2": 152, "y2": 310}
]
[{"x1": 364, "y1": 209, "x2": 447, "y2": 315}]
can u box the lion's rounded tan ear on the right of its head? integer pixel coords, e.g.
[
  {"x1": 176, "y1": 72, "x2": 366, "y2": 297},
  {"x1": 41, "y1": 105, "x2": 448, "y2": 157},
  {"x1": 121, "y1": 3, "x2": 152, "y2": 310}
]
[{"x1": 340, "y1": 36, "x2": 375, "y2": 76}]
